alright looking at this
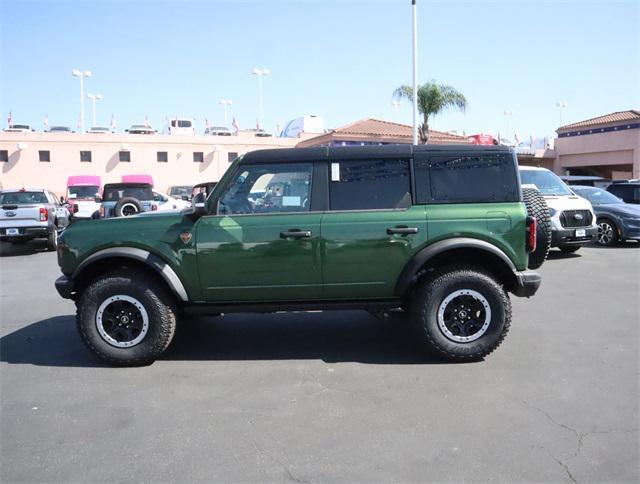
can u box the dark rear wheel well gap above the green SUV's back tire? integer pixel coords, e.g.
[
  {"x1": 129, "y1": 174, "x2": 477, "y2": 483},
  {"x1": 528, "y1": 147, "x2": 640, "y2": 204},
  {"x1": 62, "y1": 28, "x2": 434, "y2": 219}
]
[{"x1": 405, "y1": 247, "x2": 518, "y2": 296}]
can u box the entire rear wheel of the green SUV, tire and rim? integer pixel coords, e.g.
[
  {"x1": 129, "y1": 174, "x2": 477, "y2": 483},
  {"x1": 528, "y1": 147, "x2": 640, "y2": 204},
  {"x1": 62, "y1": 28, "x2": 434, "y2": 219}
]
[{"x1": 412, "y1": 267, "x2": 511, "y2": 361}]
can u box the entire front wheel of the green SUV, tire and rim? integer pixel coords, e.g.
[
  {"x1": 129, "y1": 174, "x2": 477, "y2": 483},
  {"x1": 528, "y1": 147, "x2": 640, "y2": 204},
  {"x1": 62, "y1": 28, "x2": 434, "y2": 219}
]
[{"x1": 76, "y1": 271, "x2": 177, "y2": 366}]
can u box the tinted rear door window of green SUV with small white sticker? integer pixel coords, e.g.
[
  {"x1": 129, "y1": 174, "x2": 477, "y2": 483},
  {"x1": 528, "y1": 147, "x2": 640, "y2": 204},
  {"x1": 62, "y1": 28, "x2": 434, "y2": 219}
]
[{"x1": 329, "y1": 160, "x2": 411, "y2": 210}]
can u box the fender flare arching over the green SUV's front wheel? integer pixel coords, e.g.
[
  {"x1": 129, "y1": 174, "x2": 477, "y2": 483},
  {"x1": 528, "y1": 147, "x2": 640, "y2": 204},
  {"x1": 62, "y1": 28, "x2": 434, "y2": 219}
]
[{"x1": 71, "y1": 247, "x2": 189, "y2": 302}]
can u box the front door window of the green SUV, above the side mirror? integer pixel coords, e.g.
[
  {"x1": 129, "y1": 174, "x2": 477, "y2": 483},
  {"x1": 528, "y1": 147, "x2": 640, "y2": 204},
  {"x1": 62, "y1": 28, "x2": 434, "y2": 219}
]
[{"x1": 219, "y1": 163, "x2": 312, "y2": 214}]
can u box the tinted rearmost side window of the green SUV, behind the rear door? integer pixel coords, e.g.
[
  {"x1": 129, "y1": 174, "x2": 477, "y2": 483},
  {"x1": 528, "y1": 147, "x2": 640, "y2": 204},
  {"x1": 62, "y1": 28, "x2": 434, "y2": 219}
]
[{"x1": 415, "y1": 153, "x2": 520, "y2": 203}]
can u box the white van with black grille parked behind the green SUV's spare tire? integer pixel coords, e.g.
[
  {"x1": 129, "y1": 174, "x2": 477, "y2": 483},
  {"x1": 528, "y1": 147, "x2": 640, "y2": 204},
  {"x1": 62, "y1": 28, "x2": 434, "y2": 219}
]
[{"x1": 520, "y1": 166, "x2": 598, "y2": 253}]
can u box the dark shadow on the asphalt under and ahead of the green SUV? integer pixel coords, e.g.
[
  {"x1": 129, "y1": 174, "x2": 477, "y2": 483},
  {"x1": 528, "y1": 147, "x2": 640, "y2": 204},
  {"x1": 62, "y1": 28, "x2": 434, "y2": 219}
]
[{"x1": 0, "y1": 311, "x2": 450, "y2": 367}]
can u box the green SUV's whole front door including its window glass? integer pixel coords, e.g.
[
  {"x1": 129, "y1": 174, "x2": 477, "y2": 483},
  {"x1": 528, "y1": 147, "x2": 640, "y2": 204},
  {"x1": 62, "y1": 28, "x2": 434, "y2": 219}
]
[{"x1": 196, "y1": 163, "x2": 322, "y2": 302}]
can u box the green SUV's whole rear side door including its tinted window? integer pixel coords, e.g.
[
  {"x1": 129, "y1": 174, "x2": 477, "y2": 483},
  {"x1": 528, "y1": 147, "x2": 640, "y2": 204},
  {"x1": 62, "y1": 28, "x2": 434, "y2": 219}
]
[{"x1": 322, "y1": 156, "x2": 427, "y2": 299}]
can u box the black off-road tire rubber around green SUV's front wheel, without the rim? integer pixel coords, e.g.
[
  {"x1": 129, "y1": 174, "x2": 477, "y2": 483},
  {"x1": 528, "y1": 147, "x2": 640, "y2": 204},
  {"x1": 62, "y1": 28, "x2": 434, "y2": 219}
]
[{"x1": 76, "y1": 270, "x2": 178, "y2": 366}]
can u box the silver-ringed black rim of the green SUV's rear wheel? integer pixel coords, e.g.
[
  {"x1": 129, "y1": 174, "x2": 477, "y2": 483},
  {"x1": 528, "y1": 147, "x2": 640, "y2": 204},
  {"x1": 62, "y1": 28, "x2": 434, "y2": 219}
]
[{"x1": 438, "y1": 289, "x2": 491, "y2": 343}]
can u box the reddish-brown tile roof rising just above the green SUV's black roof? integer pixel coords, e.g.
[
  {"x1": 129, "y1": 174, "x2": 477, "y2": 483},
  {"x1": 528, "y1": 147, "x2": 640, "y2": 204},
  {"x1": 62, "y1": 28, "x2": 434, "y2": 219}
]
[{"x1": 298, "y1": 118, "x2": 469, "y2": 146}]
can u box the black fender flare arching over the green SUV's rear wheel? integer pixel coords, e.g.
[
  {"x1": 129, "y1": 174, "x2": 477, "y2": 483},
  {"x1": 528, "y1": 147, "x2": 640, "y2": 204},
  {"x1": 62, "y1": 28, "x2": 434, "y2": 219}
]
[{"x1": 395, "y1": 237, "x2": 517, "y2": 297}]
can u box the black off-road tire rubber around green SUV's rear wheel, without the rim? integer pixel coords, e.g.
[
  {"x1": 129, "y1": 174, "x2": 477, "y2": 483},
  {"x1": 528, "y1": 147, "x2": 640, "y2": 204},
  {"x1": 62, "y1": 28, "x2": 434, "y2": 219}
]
[{"x1": 411, "y1": 266, "x2": 511, "y2": 362}]
